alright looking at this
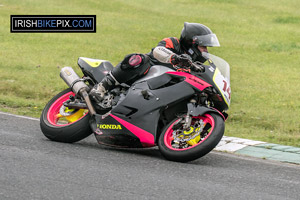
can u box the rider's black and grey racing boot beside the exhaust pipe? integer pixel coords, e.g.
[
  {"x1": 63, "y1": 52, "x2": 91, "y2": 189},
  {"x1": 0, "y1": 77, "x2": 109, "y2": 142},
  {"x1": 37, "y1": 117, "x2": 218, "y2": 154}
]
[{"x1": 89, "y1": 73, "x2": 119, "y2": 103}]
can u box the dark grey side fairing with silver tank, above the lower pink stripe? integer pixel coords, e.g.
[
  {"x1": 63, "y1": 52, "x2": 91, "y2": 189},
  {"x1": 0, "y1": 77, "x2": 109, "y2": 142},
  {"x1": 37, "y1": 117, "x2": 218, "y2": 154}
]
[{"x1": 111, "y1": 65, "x2": 195, "y2": 139}]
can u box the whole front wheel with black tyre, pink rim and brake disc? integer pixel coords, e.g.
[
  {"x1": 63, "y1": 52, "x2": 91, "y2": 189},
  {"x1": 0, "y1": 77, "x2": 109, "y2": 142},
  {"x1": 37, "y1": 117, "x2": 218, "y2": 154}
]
[{"x1": 158, "y1": 113, "x2": 225, "y2": 162}]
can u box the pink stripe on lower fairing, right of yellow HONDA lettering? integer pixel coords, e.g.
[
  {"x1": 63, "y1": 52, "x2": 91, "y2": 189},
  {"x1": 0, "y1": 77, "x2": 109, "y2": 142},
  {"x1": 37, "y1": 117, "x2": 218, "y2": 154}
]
[{"x1": 110, "y1": 114, "x2": 155, "y2": 147}]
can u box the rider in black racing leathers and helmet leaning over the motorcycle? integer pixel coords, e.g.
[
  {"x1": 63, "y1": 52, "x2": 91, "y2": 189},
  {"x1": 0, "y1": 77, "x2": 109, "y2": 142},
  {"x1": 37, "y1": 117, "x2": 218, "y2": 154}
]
[{"x1": 90, "y1": 22, "x2": 220, "y2": 102}]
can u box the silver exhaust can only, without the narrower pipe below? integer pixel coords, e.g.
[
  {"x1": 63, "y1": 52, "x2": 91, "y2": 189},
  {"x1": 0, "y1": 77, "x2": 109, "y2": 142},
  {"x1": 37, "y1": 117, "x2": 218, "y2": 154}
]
[{"x1": 60, "y1": 67, "x2": 89, "y2": 94}]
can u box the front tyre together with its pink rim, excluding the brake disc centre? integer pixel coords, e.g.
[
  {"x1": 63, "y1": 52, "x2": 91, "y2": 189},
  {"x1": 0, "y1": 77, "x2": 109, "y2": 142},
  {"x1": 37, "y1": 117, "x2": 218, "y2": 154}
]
[{"x1": 158, "y1": 113, "x2": 225, "y2": 162}]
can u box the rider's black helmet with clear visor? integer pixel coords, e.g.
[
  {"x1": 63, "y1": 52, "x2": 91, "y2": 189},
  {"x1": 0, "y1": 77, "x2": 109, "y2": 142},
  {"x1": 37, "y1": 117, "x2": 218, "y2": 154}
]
[{"x1": 180, "y1": 22, "x2": 220, "y2": 63}]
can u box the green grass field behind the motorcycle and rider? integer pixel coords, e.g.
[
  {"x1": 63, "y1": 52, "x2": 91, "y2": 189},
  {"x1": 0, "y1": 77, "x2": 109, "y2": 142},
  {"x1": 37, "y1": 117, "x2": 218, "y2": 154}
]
[{"x1": 0, "y1": 0, "x2": 300, "y2": 147}]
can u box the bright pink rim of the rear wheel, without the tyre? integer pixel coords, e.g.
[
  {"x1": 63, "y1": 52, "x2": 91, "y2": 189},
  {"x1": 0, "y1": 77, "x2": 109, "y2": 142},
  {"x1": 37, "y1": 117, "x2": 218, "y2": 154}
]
[{"x1": 47, "y1": 92, "x2": 87, "y2": 126}]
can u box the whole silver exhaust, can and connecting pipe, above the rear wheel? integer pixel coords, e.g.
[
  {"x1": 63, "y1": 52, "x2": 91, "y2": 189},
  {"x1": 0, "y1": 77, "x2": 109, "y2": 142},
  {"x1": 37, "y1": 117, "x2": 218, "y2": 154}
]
[{"x1": 60, "y1": 67, "x2": 96, "y2": 116}]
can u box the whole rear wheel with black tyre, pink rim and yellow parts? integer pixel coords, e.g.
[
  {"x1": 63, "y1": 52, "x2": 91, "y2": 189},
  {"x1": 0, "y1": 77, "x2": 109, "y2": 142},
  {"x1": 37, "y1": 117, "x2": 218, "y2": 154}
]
[{"x1": 40, "y1": 88, "x2": 92, "y2": 143}]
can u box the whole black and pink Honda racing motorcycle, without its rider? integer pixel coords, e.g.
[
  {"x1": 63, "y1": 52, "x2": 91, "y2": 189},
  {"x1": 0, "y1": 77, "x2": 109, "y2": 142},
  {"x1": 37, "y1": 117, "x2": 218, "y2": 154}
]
[{"x1": 40, "y1": 53, "x2": 231, "y2": 162}]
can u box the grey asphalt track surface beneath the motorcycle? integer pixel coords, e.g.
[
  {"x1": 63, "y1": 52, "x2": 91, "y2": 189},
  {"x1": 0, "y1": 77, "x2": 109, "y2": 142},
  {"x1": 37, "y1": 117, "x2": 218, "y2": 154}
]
[{"x1": 0, "y1": 113, "x2": 300, "y2": 200}]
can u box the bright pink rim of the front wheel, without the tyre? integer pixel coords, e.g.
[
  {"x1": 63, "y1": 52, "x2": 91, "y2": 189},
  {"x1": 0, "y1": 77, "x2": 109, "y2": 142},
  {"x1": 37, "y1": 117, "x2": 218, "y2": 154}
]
[{"x1": 164, "y1": 114, "x2": 215, "y2": 151}]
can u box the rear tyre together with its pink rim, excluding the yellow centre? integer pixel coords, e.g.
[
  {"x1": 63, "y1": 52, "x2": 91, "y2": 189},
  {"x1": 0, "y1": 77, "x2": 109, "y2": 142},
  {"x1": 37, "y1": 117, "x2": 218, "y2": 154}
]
[{"x1": 40, "y1": 88, "x2": 93, "y2": 143}]
